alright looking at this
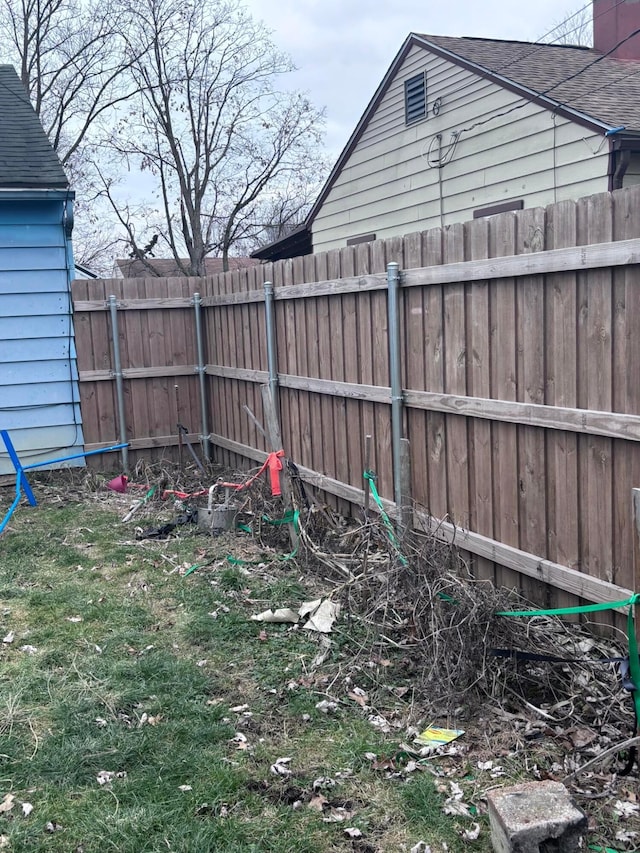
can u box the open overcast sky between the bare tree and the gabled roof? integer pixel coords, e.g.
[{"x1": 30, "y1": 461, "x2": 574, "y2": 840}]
[{"x1": 245, "y1": 0, "x2": 586, "y2": 156}]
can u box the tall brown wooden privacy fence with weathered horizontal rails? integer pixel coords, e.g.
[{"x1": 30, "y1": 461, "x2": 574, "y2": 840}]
[{"x1": 73, "y1": 187, "x2": 640, "y2": 606}]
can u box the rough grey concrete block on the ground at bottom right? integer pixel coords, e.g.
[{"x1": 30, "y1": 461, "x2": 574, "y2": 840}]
[{"x1": 487, "y1": 781, "x2": 587, "y2": 853}]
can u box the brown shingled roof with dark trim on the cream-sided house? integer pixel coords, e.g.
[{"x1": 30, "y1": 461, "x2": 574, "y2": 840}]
[{"x1": 253, "y1": 33, "x2": 640, "y2": 260}]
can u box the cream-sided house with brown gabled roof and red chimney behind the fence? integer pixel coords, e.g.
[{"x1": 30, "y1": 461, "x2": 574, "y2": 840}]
[{"x1": 253, "y1": 0, "x2": 640, "y2": 260}]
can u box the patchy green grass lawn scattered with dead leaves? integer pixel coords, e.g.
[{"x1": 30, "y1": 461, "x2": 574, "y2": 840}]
[{"x1": 0, "y1": 472, "x2": 633, "y2": 853}]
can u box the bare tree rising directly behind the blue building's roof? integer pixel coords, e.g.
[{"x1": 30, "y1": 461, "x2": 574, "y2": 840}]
[{"x1": 0, "y1": 0, "x2": 150, "y2": 272}]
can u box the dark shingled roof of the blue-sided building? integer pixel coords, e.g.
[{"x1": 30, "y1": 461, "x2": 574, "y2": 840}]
[{"x1": 0, "y1": 65, "x2": 69, "y2": 189}]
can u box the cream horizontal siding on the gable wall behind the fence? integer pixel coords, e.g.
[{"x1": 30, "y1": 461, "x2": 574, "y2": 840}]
[{"x1": 312, "y1": 47, "x2": 609, "y2": 252}]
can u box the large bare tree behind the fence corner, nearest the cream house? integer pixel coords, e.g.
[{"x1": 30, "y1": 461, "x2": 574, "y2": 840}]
[{"x1": 105, "y1": 0, "x2": 325, "y2": 275}]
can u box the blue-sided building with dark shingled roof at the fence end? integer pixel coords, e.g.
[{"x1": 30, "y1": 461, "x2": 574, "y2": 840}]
[{"x1": 0, "y1": 65, "x2": 84, "y2": 474}]
